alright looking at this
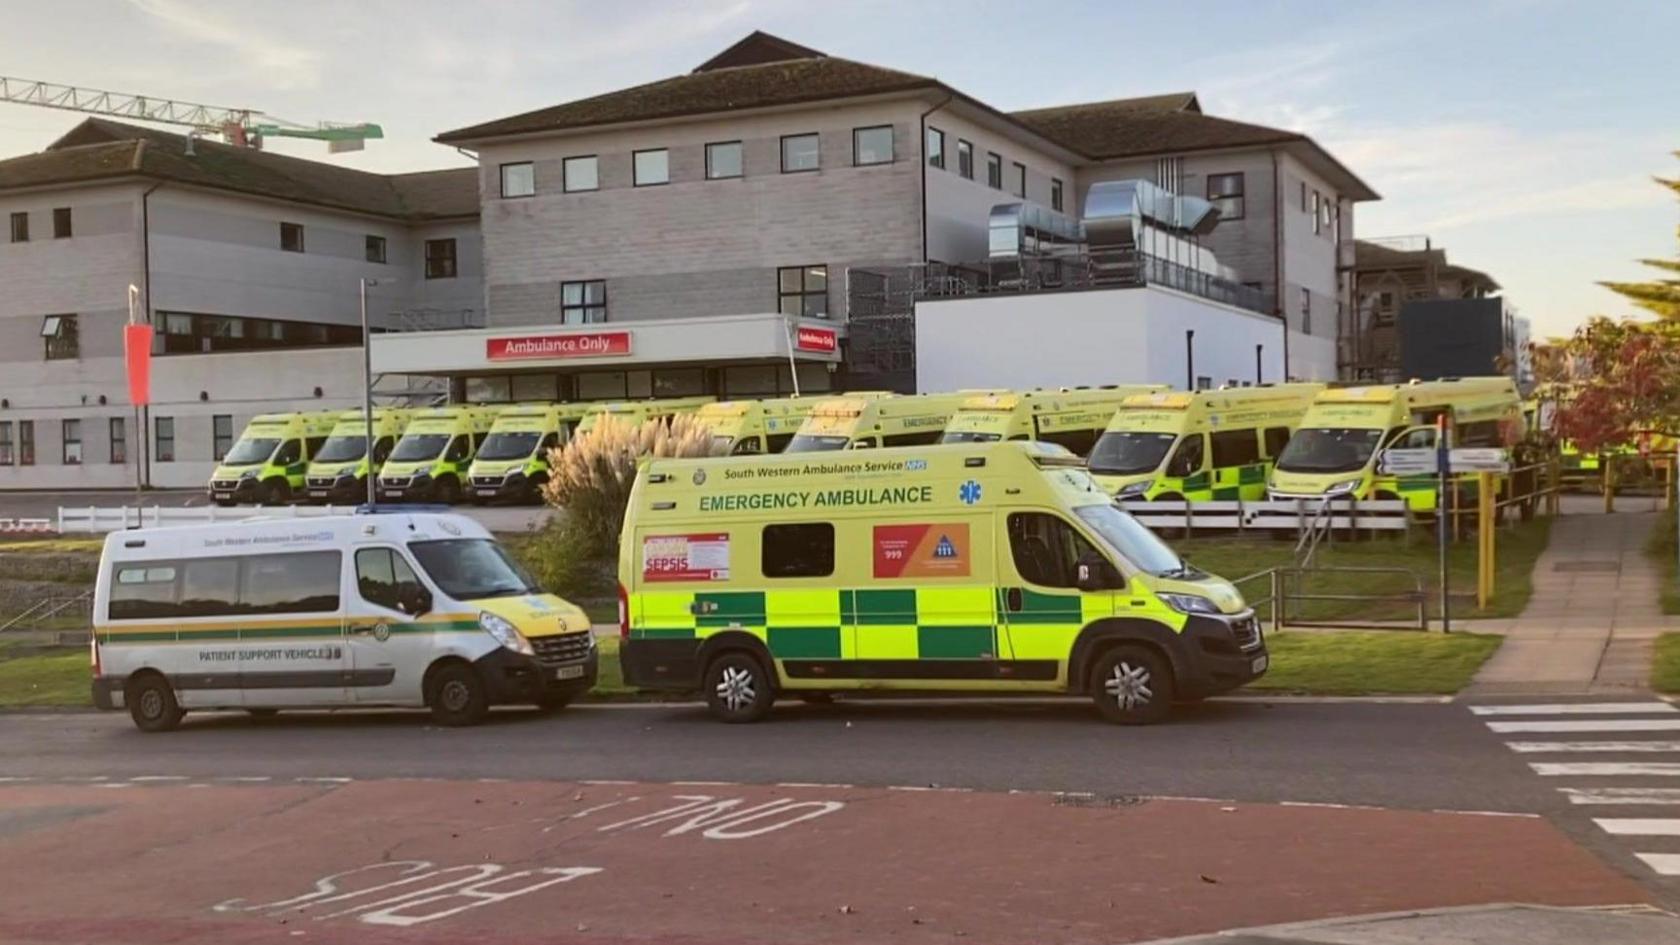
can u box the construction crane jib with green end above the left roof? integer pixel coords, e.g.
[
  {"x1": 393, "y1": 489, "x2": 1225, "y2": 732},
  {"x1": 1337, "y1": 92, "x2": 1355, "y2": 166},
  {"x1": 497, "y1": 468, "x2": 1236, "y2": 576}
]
[{"x1": 0, "y1": 76, "x2": 385, "y2": 155}]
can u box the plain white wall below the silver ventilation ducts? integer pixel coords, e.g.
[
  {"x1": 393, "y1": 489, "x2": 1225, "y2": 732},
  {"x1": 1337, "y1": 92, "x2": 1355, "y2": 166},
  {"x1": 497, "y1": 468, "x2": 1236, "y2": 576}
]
[{"x1": 916, "y1": 286, "x2": 1284, "y2": 392}]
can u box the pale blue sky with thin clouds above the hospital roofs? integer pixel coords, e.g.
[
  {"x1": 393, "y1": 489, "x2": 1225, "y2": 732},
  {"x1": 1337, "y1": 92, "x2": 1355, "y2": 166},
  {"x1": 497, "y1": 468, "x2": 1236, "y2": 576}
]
[{"x1": 0, "y1": 0, "x2": 1680, "y2": 336}]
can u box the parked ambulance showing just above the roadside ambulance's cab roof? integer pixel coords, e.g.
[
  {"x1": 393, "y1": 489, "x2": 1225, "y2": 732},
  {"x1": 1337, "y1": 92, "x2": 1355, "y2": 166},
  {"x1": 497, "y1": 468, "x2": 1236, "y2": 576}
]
[{"x1": 939, "y1": 383, "x2": 1166, "y2": 456}]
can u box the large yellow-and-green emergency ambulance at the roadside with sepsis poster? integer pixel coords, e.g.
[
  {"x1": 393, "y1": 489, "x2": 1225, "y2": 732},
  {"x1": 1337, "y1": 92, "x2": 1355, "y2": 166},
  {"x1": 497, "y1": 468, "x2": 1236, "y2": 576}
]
[{"x1": 618, "y1": 442, "x2": 1270, "y2": 723}]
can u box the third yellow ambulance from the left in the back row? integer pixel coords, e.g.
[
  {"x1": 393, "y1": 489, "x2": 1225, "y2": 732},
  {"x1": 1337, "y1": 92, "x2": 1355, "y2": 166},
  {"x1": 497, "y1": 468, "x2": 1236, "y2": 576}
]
[{"x1": 376, "y1": 405, "x2": 499, "y2": 503}]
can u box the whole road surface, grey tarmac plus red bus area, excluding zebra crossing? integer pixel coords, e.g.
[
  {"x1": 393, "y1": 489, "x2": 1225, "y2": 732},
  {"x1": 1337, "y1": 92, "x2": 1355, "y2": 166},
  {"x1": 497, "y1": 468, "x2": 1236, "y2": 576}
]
[{"x1": 0, "y1": 700, "x2": 1673, "y2": 945}]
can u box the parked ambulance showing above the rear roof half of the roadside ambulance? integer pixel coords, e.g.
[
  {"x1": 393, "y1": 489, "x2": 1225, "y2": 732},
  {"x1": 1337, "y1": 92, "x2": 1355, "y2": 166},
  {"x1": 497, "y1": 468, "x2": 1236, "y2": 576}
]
[{"x1": 785, "y1": 390, "x2": 974, "y2": 452}]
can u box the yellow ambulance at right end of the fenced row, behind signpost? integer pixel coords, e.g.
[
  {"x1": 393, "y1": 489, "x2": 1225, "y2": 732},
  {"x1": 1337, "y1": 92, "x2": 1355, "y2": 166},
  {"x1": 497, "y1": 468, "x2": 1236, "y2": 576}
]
[{"x1": 1267, "y1": 377, "x2": 1524, "y2": 515}]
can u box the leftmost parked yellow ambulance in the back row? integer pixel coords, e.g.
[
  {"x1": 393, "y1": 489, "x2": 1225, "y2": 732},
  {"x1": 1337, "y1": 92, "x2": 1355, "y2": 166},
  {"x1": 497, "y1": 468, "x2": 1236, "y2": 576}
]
[{"x1": 208, "y1": 410, "x2": 338, "y2": 506}]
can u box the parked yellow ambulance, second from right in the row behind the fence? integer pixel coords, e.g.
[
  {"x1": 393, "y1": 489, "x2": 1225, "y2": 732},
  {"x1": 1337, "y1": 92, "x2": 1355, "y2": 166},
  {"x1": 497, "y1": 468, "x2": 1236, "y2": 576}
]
[{"x1": 1089, "y1": 383, "x2": 1324, "y2": 501}]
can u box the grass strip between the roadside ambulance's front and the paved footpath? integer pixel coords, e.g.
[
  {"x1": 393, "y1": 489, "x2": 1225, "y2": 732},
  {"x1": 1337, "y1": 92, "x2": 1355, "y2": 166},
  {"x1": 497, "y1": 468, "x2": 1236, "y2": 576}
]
[{"x1": 1248, "y1": 631, "x2": 1512, "y2": 696}]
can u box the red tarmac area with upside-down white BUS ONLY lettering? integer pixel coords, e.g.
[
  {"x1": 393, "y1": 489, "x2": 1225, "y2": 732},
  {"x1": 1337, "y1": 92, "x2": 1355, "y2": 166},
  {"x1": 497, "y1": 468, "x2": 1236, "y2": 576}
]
[{"x1": 0, "y1": 780, "x2": 1646, "y2": 945}]
